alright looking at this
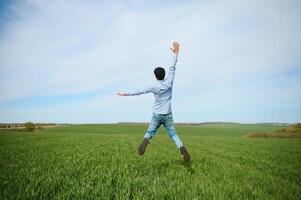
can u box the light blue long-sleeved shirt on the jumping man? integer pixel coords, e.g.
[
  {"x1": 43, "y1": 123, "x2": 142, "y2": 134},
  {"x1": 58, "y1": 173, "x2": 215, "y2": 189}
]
[{"x1": 127, "y1": 55, "x2": 178, "y2": 114}]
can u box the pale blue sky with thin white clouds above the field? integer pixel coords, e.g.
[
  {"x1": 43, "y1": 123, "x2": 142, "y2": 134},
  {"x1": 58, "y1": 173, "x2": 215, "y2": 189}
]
[{"x1": 0, "y1": 0, "x2": 301, "y2": 123}]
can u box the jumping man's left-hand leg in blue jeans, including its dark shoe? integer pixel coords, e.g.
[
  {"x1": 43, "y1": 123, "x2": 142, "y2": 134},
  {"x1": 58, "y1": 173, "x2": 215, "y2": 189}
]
[{"x1": 138, "y1": 114, "x2": 161, "y2": 155}]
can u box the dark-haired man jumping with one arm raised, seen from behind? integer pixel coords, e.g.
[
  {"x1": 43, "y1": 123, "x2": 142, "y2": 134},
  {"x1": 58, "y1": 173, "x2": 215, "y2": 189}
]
[{"x1": 117, "y1": 42, "x2": 190, "y2": 162}]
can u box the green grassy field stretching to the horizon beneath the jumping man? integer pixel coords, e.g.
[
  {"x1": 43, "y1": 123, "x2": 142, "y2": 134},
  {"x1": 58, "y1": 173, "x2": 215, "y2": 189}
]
[{"x1": 0, "y1": 124, "x2": 301, "y2": 200}]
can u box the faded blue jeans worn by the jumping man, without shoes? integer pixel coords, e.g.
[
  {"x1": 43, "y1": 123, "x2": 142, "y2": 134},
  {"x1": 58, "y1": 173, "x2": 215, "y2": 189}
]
[{"x1": 144, "y1": 113, "x2": 183, "y2": 148}]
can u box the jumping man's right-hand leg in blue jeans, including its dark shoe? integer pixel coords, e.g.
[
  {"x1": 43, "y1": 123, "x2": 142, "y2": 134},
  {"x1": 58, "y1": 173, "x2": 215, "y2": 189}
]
[{"x1": 163, "y1": 113, "x2": 190, "y2": 162}]
